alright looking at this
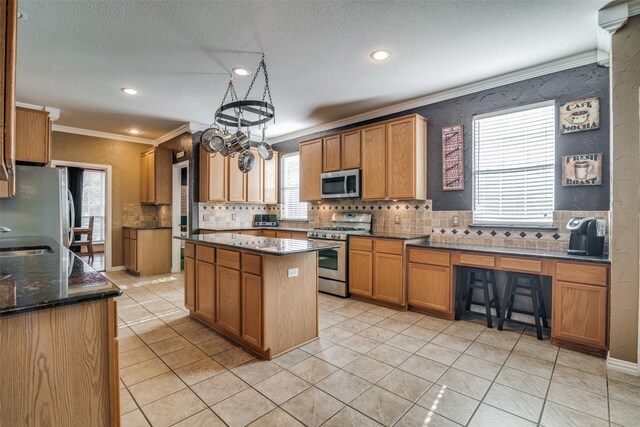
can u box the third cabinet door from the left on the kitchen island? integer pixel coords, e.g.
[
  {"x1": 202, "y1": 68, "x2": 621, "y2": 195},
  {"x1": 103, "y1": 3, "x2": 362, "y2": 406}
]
[{"x1": 216, "y1": 265, "x2": 242, "y2": 337}]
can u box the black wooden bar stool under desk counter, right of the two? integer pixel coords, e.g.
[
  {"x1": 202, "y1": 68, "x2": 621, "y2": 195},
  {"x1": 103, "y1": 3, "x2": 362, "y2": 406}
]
[{"x1": 498, "y1": 272, "x2": 549, "y2": 340}]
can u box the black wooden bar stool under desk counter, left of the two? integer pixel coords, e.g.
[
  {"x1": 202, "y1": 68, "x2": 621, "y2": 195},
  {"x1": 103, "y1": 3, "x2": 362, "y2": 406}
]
[{"x1": 455, "y1": 267, "x2": 500, "y2": 328}]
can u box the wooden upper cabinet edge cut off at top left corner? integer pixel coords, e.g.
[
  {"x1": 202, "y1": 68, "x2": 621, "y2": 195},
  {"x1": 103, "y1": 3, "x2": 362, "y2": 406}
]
[{"x1": 0, "y1": 0, "x2": 18, "y2": 198}]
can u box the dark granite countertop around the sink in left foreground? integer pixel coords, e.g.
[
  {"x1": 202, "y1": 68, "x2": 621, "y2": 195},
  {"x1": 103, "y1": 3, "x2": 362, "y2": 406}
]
[{"x1": 0, "y1": 237, "x2": 122, "y2": 316}]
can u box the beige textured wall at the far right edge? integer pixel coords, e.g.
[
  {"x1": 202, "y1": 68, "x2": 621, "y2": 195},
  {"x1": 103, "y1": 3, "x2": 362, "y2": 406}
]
[{"x1": 610, "y1": 16, "x2": 640, "y2": 363}]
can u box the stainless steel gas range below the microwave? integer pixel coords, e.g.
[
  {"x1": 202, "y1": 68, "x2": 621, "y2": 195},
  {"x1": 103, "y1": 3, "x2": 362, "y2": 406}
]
[{"x1": 307, "y1": 212, "x2": 371, "y2": 297}]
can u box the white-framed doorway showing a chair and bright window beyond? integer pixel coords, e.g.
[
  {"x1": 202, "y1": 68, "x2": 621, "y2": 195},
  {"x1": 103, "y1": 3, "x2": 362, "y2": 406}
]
[{"x1": 51, "y1": 160, "x2": 112, "y2": 271}]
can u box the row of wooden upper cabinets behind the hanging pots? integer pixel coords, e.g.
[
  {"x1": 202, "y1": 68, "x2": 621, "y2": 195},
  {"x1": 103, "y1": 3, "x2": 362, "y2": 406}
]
[{"x1": 199, "y1": 147, "x2": 279, "y2": 204}]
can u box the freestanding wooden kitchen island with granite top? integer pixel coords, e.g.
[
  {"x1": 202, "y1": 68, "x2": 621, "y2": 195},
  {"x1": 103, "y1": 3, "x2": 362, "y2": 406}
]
[{"x1": 174, "y1": 233, "x2": 337, "y2": 359}]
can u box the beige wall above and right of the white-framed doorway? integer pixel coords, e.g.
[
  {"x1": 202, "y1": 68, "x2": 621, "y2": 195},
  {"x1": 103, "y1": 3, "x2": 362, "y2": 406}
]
[{"x1": 52, "y1": 132, "x2": 151, "y2": 266}]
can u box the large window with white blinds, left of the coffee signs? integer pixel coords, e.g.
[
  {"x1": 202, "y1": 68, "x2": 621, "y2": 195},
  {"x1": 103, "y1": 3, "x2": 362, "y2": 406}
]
[{"x1": 473, "y1": 101, "x2": 555, "y2": 227}]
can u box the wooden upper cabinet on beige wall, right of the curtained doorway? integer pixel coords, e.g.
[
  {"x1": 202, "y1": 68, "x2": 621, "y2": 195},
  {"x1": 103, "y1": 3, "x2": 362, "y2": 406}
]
[{"x1": 140, "y1": 147, "x2": 173, "y2": 205}]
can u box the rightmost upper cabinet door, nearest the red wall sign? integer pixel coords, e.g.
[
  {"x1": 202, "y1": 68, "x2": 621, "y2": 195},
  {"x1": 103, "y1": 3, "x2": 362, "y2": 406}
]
[{"x1": 387, "y1": 117, "x2": 416, "y2": 199}]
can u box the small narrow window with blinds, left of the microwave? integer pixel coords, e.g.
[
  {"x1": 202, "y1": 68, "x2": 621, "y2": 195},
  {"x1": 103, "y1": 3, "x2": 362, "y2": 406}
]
[{"x1": 280, "y1": 153, "x2": 307, "y2": 221}]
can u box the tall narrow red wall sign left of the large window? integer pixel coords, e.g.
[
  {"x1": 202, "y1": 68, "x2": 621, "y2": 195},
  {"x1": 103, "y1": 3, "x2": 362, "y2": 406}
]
[{"x1": 442, "y1": 125, "x2": 464, "y2": 191}]
